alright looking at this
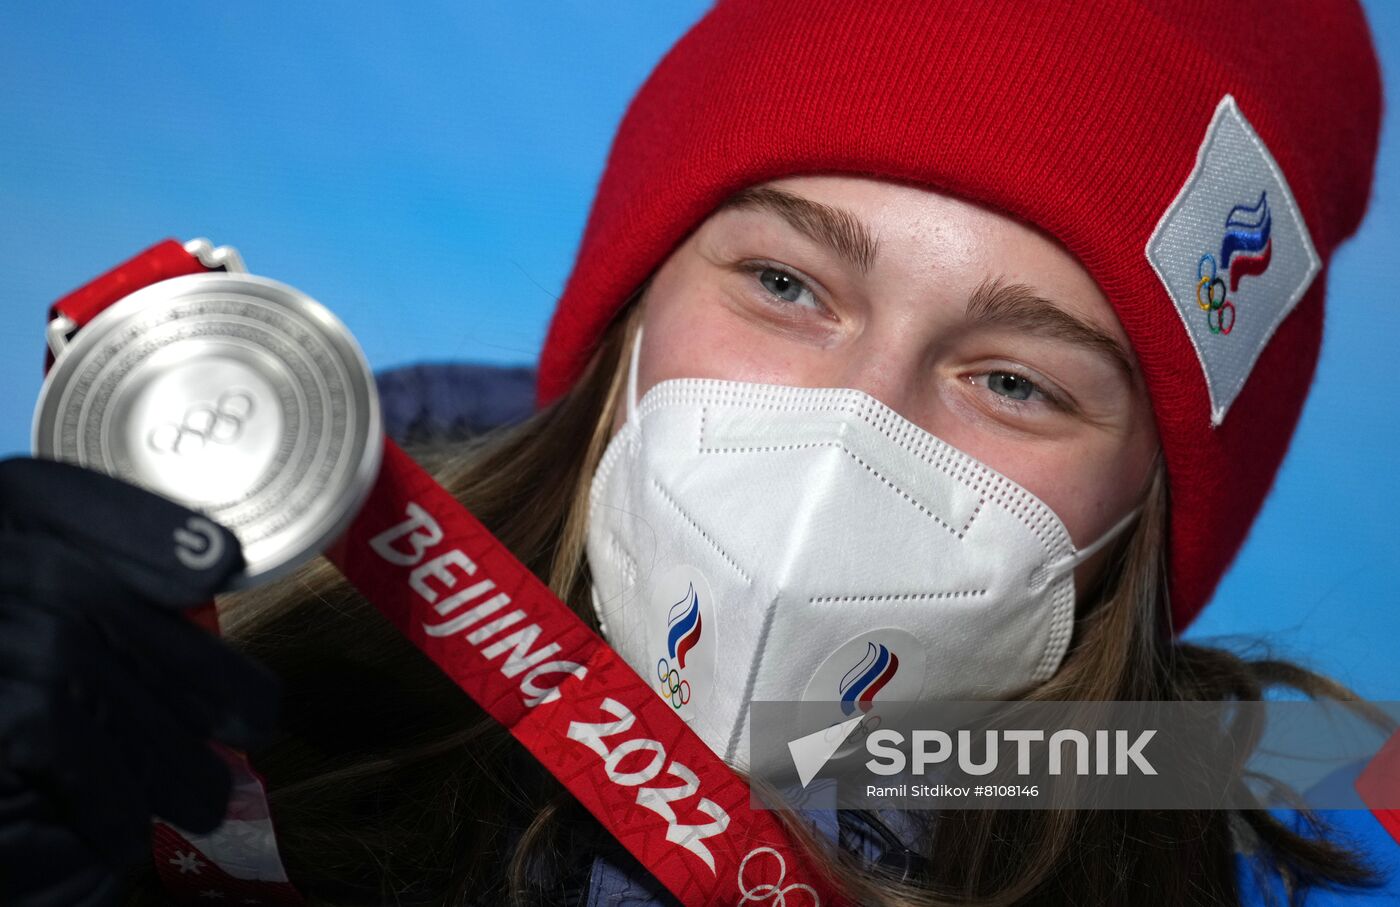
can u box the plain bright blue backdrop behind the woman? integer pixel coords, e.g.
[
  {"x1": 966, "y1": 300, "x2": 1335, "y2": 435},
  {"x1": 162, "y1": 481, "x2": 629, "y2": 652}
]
[{"x1": 0, "y1": 0, "x2": 1400, "y2": 700}]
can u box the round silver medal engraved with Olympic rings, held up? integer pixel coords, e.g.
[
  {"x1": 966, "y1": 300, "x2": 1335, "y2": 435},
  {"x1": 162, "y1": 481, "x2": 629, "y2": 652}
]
[{"x1": 32, "y1": 247, "x2": 384, "y2": 588}]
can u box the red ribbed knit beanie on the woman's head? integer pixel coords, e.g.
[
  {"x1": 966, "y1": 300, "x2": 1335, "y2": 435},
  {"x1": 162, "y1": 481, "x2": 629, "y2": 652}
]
[{"x1": 538, "y1": 0, "x2": 1380, "y2": 631}]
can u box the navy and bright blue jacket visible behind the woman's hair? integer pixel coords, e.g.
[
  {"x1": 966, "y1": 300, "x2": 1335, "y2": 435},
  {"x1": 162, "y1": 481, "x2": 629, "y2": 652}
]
[{"x1": 377, "y1": 363, "x2": 1400, "y2": 907}]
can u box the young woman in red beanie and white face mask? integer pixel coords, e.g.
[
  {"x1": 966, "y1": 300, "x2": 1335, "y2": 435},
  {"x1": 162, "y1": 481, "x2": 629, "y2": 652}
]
[{"x1": 5, "y1": 0, "x2": 1400, "y2": 904}]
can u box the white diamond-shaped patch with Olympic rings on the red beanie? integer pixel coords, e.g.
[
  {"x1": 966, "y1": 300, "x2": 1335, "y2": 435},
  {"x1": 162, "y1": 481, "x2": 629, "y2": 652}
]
[{"x1": 1147, "y1": 95, "x2": 1322, "y2": 426}]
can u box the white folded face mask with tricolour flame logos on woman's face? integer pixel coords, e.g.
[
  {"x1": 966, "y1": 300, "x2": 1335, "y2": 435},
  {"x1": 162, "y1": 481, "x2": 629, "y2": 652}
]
[{"x1": 588, "y1": 329, "x2": 1137, "y2": 768}]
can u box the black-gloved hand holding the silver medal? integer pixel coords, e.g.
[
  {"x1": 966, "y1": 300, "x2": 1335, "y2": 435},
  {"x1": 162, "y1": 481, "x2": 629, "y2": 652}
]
[{"x1": 0, "y1": 458, "x2": 280, "y2": 907}]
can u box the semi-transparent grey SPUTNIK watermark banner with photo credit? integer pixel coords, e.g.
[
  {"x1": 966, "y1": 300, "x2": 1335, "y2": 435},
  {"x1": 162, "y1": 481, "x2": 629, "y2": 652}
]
[{"x1": 749, "y1": 701, "x2": 1400, "y2": 809}]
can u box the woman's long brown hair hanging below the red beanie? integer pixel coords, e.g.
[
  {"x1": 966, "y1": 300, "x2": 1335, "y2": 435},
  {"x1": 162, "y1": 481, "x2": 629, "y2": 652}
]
[{"x1": 129, "y1": 299, "x2": 1371, "y2": 907}]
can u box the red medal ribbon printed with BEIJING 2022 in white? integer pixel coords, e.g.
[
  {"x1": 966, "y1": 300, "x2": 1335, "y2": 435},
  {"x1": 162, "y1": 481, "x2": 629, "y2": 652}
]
[{"x1": 46, "y1": 241, "x2": 841, "y2": 907}]
